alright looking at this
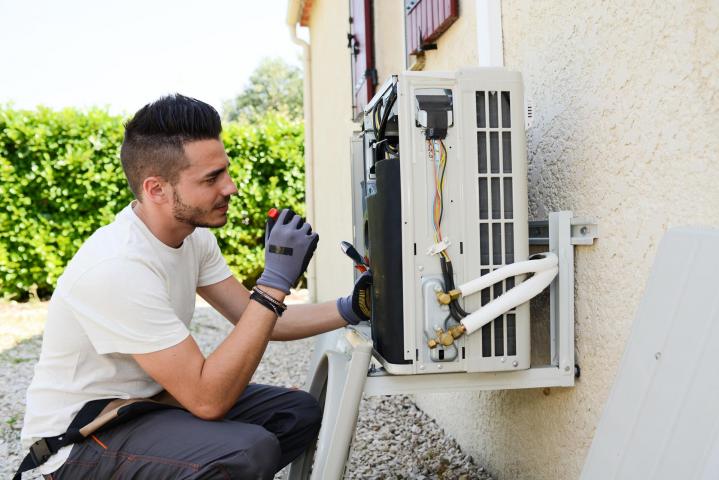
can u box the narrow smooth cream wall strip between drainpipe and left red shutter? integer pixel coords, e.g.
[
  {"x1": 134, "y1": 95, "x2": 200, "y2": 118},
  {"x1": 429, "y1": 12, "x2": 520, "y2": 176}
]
[{"x1": 308, "y1": 0, "x2": 357, "y2": 301}]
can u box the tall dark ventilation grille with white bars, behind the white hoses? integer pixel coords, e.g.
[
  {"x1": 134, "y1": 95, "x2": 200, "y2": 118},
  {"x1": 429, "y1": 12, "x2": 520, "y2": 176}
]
[{"x1": 476, "y1": 91, "x2": 517, "y2": 357}]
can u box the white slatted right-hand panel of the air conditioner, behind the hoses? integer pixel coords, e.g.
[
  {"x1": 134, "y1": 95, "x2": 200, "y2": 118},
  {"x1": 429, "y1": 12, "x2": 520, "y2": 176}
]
[{"x1": 458, "y1": 68, "x2": 530, "y2": 372}]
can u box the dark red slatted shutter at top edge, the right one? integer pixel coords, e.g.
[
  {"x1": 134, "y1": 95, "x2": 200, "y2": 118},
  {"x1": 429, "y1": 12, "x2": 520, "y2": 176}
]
[{"x1": 405, "y1": 0, "x2": 459, "y2": 55}]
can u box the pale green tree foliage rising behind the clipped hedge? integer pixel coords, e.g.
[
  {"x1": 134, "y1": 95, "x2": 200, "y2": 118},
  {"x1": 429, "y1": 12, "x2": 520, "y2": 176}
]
[{"x1": 224, "y1": 58, "x2": 303, "y2": 121}]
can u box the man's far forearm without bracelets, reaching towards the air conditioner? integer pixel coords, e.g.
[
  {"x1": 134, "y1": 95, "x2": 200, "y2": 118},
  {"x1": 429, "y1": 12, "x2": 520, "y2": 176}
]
[{"x1": 271, "y1": 300, "x2": 347, "y2": 341}]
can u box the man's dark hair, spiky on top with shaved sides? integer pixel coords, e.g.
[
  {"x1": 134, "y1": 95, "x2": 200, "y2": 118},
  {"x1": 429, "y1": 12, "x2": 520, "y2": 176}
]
[{"x1": 120, "y1": 93, "x2": 222, "y2": 200}]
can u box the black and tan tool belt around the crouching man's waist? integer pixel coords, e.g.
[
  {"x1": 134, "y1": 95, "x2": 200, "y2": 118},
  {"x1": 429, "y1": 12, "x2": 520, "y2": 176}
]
[{"x1": 13, "y1": 390, "x2": 183, "y2": 480}]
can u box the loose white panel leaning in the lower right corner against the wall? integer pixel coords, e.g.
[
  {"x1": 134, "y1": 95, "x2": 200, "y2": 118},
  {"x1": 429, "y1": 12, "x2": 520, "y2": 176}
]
[{"x1": 581, "y1": 229, "x2": 719, "y2": 480}]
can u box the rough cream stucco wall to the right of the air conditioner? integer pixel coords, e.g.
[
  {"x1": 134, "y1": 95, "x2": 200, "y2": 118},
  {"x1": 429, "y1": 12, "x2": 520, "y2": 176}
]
[{"x1": 417, "y1": 0, "x2": 719, "y2": 480}]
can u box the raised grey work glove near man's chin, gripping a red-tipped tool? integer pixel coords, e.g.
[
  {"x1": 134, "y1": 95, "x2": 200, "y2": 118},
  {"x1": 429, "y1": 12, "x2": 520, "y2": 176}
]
[{"x1": 257, "y1": 208, "x2": 320, "y2": 294}]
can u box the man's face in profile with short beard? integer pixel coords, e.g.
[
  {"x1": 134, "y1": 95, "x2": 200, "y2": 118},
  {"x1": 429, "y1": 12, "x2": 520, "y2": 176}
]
[{"x1": 172, "y1": 140, "x2": 237, "y2": 227}]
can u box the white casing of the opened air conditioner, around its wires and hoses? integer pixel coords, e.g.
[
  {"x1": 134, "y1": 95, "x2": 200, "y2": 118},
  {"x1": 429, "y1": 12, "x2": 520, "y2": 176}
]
[{"x1": 366, "y1": 68, "x2": 530, "y2": 374}]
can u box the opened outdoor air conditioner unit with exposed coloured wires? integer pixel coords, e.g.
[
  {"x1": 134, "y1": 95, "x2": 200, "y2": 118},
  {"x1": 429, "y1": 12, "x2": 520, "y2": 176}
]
[{"x1": 353, "y1": 68, "x2": 536, "y2": 374}]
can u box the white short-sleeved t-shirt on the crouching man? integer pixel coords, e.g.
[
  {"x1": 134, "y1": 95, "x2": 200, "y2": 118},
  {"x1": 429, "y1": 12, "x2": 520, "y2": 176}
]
[{"x1": 21, "y1": 205, "x2": 231, "y2": 474}]
